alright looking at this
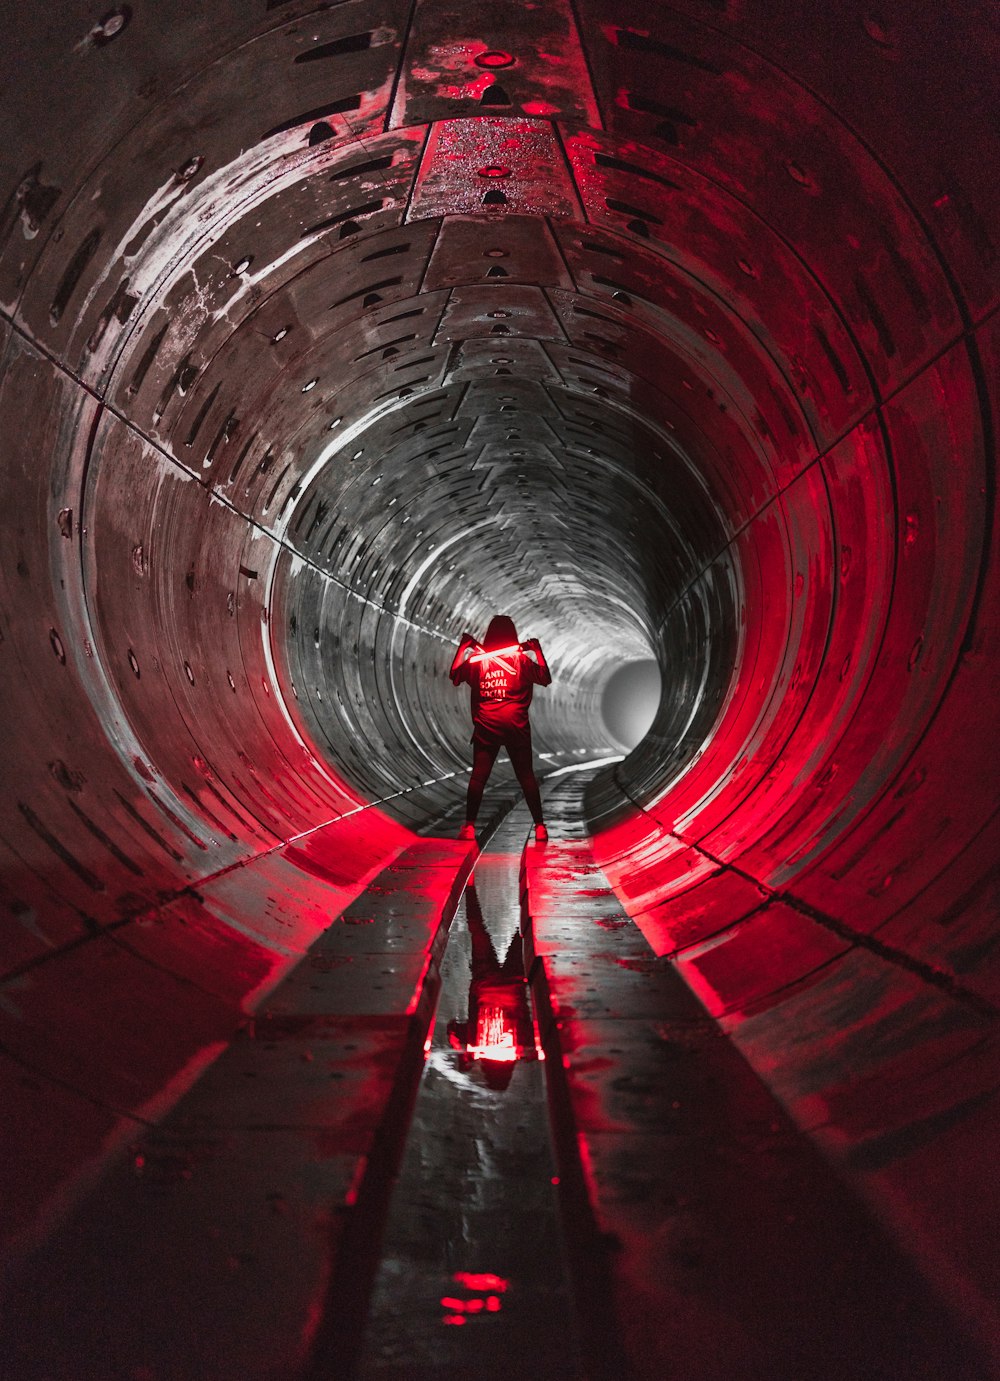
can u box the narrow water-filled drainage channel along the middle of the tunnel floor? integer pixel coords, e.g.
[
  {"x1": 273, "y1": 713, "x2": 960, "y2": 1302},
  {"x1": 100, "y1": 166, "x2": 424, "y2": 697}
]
[{"x1": 358, "y1": 807, "x2": 584, "y2": 1381}]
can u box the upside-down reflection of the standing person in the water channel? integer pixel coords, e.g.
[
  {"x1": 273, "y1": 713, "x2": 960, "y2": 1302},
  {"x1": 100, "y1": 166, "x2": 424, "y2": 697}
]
[{"x1": 448, "y1": 882, "x2": 536, "y2": 1088}]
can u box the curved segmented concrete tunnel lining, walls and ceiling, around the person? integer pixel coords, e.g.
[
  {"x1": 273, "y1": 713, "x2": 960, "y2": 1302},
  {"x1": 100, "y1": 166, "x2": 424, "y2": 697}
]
[{"x1": 0, "y1": 0, "x2": 997, "y2": 1358}]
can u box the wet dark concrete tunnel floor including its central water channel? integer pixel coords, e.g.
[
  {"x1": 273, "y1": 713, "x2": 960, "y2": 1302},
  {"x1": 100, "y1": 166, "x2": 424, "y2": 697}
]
[{"x1": 0, "y1": 773, "x2": 990, "y2": 1381}]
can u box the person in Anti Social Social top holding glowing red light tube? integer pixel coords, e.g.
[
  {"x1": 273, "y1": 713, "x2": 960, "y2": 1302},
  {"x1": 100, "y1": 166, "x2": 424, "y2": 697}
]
[{"x1": 450, "y1": 615, "x2": 552, "y2": 841}]
